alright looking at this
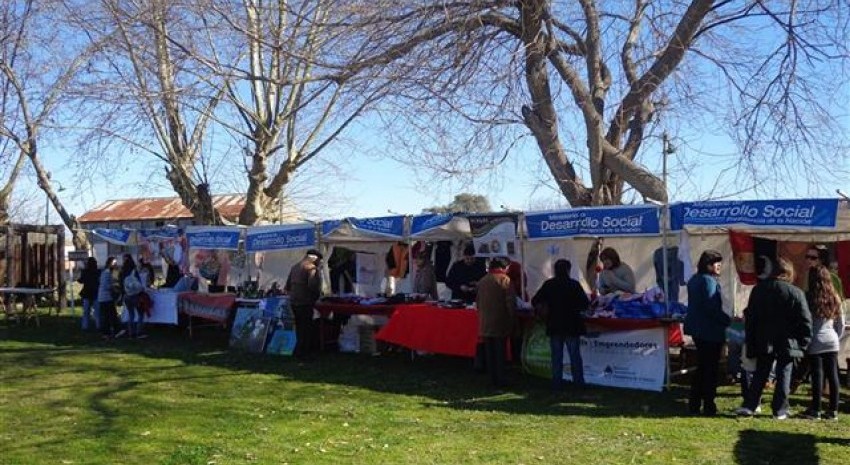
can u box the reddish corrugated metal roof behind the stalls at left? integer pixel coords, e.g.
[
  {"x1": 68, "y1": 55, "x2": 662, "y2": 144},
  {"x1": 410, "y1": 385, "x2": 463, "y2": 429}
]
[{"x1": 78, "y1": 194, "x2": 245, "y2": 223}]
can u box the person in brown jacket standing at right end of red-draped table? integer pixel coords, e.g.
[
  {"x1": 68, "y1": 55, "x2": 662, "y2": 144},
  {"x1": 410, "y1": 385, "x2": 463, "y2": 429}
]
[{"x1": 476, "y1": 258, "x2": 516, "y2": 387}]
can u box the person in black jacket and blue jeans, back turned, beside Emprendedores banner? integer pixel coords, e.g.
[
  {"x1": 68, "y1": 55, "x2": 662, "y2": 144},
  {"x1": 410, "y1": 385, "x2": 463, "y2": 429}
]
[{"x1": 531, "y1": 259, "x2": 590, "y2": 390}]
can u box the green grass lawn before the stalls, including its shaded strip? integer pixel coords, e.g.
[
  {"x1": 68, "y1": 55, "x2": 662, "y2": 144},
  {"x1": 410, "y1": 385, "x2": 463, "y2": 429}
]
[{"x1": 0, "y1": 316, "x2": 850, "y2": 465}]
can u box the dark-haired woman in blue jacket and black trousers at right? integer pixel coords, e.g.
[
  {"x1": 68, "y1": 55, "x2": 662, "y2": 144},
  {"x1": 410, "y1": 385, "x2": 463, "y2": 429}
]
[{"x1": 685, "y1": 250, "x2": 732, "y2": 416}]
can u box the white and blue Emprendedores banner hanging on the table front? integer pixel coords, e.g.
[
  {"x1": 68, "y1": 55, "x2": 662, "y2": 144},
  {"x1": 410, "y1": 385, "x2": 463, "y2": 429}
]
[{"x1": 580, "y1": 327, "x2": 667, "y2": 391}]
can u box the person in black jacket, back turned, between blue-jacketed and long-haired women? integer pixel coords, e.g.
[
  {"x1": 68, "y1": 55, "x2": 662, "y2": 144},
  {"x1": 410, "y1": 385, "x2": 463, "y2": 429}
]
[{"x1": 736, "y1": 257, "x2": 812, "y2": 420}]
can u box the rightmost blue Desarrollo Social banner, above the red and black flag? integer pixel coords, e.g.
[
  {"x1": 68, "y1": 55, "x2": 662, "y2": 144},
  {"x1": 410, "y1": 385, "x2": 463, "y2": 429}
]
[{"x1": 670, "y1": 199, "x2": 838, "y2": 230}]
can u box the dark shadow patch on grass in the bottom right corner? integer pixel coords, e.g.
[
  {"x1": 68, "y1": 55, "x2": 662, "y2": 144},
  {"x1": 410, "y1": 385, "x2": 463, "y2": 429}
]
[{"x1": 734, "y1": 429, "x2": 850, "y2": 465}]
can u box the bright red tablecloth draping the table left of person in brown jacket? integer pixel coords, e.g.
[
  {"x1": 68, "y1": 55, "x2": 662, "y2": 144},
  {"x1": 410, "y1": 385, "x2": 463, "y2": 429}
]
[{"x1": 375, "y1": 304, "x2": 478, "y2": 357}]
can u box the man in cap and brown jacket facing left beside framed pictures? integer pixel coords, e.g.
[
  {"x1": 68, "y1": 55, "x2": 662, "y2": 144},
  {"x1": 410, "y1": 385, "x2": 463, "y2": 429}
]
[{"x1": 284, "y1": 249, "x2": 322, "y2": 360}]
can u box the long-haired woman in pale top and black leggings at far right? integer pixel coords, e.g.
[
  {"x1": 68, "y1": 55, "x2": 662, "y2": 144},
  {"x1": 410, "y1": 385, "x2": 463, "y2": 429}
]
[{"x1": 801, "y1": 265, "x2": 844, "y2": 420}]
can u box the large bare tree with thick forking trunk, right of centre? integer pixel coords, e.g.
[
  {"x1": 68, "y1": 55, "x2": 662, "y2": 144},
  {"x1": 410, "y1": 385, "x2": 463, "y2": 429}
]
[{"x1": 342, "y1": 0, "x2": 850, "y2": 206}]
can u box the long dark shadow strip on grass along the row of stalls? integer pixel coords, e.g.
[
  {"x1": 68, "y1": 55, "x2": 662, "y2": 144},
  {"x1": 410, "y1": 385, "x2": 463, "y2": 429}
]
[{"x1": 0, "y1": 316, "x2": 800, "y2": 418}]
